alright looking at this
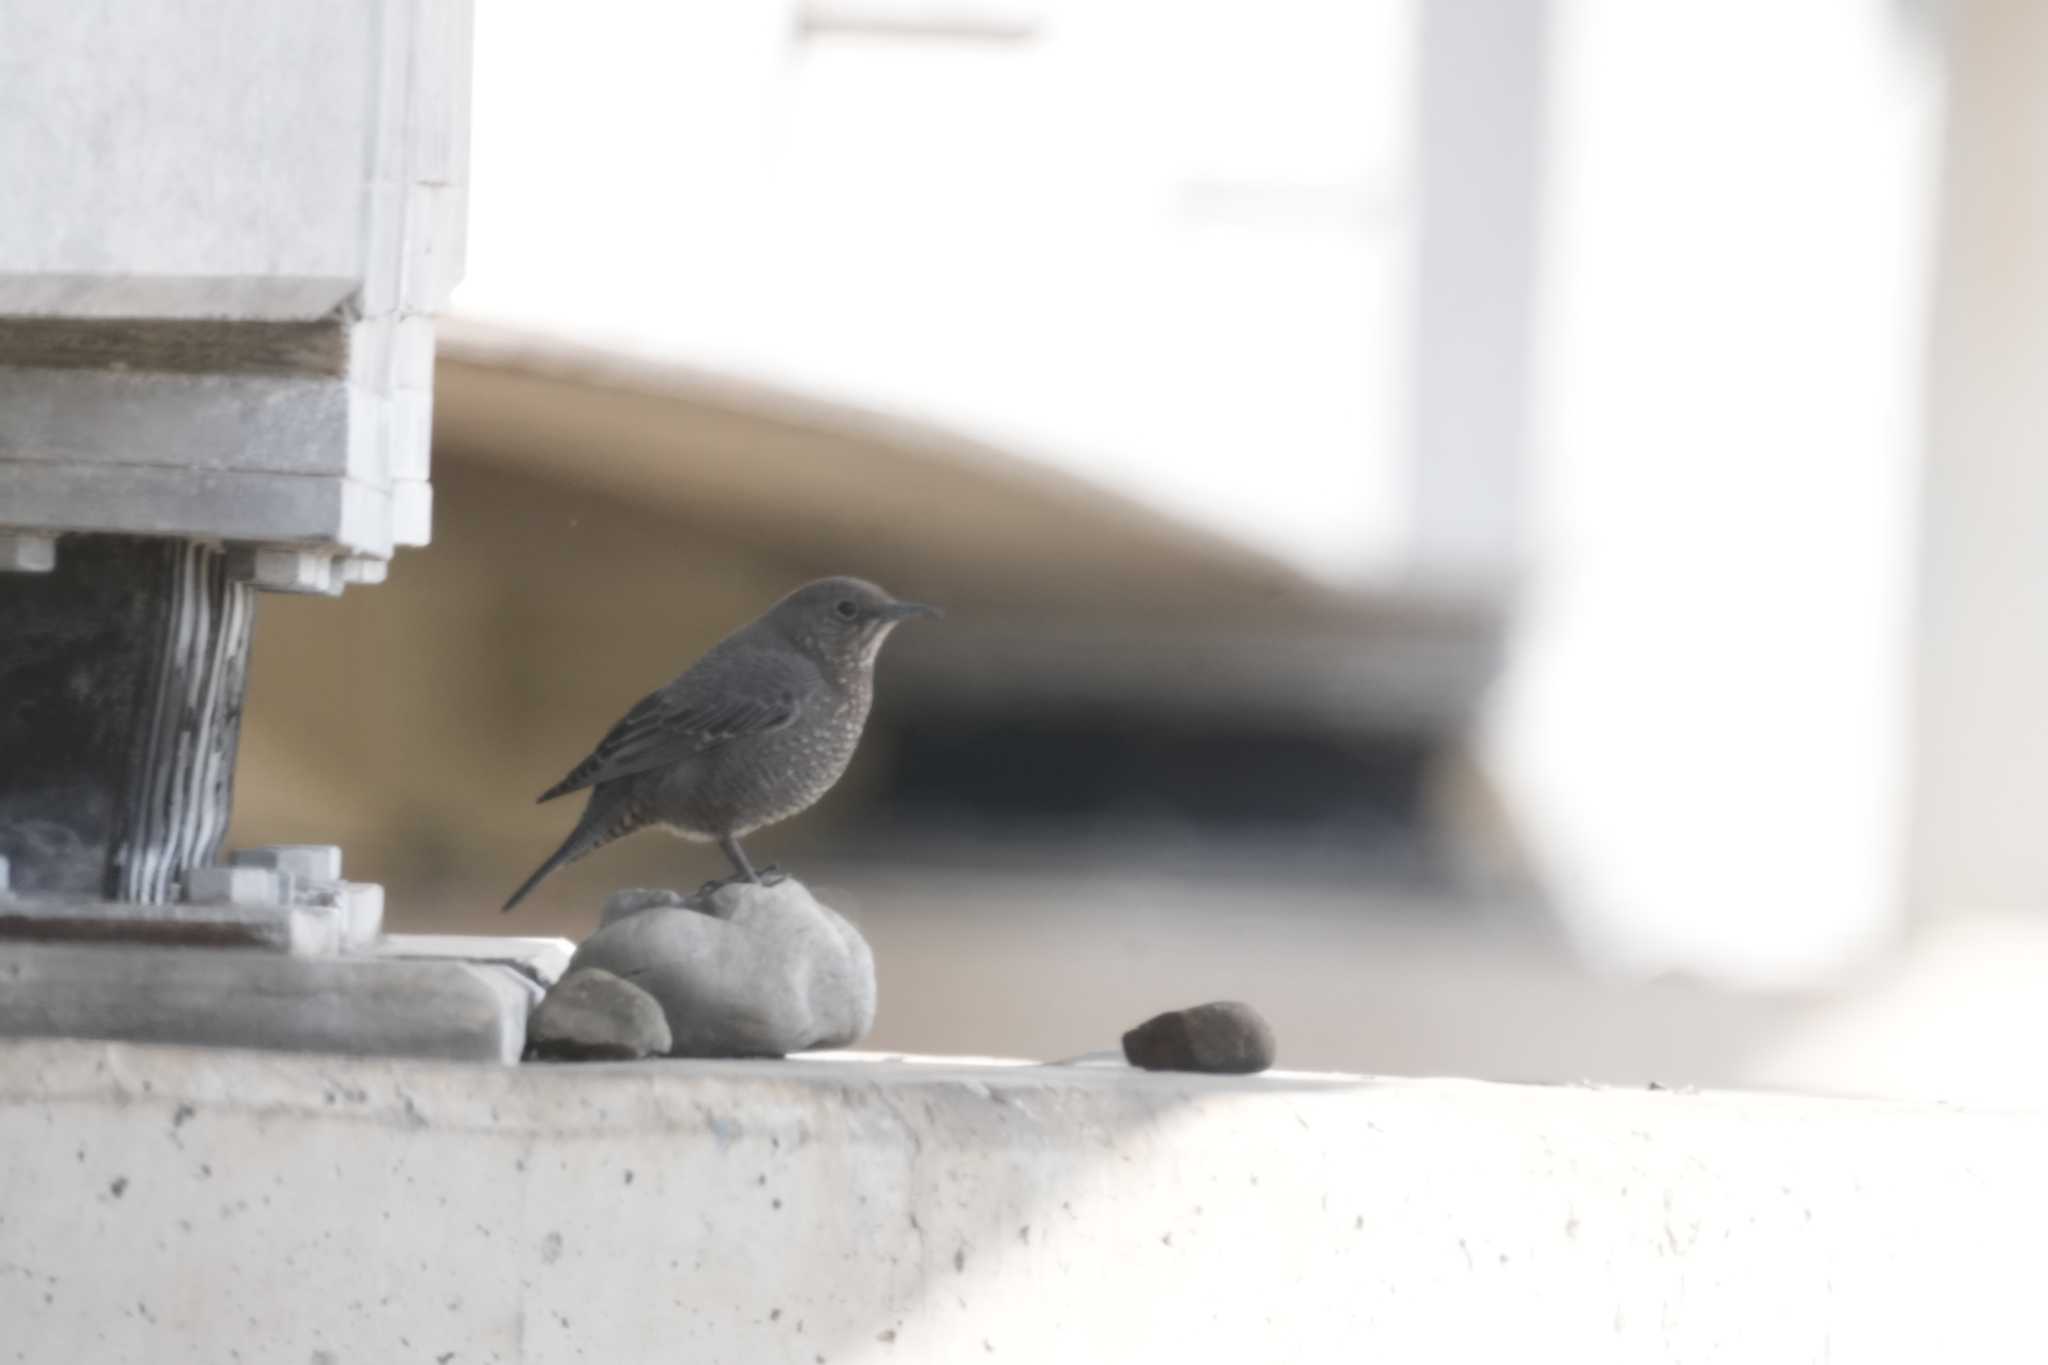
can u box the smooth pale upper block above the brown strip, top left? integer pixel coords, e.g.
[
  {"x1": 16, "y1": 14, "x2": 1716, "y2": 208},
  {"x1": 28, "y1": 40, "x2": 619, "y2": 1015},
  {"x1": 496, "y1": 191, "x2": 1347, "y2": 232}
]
[{"x1": 0, "y1": 0, "x2": 469, "y2": 319}]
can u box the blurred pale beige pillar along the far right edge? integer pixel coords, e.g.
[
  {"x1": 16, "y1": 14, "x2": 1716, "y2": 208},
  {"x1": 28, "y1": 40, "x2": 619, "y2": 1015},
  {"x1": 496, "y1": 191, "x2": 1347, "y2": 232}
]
[{"x1": 1913, "y1": 0, "x2": 2048, "y2": 911}]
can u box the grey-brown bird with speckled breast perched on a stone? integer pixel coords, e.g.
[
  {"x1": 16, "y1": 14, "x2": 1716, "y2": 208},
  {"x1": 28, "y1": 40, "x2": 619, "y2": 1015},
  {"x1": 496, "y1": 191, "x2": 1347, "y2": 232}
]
[{"x1": 506, "y1": 577, "x2": 938, "y2": 911}]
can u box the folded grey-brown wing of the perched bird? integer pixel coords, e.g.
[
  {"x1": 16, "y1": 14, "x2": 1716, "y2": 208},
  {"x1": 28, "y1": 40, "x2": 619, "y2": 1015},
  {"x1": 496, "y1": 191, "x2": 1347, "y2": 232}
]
[{"x1": 541, "y1": 651, "x2": 815, "y2": 800}]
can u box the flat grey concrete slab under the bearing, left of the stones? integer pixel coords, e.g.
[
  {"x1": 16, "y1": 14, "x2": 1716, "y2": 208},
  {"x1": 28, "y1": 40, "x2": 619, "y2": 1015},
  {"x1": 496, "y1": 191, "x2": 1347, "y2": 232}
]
[{"x1": 0, "y1": 941, "x2": 541, "y2": 1062}]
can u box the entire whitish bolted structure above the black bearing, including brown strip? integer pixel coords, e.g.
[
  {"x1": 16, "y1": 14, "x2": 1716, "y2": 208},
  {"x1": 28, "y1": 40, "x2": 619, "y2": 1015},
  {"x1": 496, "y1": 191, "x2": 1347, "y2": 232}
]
[{"x1": 0, "y1": 0, "x2": 469, "y2": 577}]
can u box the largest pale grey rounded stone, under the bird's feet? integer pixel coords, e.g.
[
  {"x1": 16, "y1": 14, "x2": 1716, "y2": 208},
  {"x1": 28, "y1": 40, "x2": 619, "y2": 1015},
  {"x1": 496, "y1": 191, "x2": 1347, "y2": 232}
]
[{"x1": 569, "y1": 880, "x2": 874, "y2": 1056}]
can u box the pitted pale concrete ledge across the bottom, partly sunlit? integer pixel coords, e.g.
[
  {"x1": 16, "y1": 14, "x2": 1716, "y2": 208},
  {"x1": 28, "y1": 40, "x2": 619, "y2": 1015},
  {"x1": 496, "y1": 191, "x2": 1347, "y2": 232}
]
[{"x1": 0, "y1": 1042, "x2": 2048, "y2": 1365}]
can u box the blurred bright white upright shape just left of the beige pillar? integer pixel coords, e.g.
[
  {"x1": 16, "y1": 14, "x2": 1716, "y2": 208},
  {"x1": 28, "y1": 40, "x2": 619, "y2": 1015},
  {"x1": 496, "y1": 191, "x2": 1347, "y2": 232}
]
[{"x1": 1489, "y1": 0, "x2": 1942, "y2": 984}]
